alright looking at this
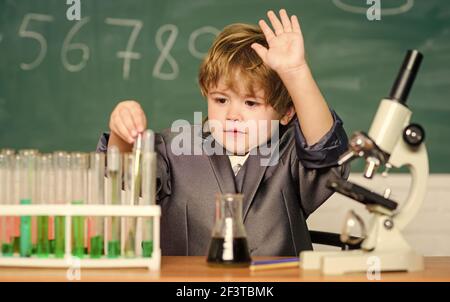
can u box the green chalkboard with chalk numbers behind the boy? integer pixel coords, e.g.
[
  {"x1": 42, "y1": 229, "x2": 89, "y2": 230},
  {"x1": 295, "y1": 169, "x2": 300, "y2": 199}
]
[{"x1": 0, "y1": 0, "x2": 450, "y2": 173}]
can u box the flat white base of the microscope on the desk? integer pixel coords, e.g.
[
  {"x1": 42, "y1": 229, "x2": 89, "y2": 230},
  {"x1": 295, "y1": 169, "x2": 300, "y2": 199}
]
[{"x1": 300, "y1": 250, "x2": 424, "y2": 275}]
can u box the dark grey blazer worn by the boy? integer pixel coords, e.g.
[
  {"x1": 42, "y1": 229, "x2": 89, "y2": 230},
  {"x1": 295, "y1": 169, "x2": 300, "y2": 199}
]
[{"x1": 97, "y1": 111, "x2": 349, "y2": 256}]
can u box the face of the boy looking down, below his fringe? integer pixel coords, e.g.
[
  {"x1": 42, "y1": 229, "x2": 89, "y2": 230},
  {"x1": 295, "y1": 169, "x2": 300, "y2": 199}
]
[{"x1": 207, "y1": 74, "x2": 290, "y2": 155}]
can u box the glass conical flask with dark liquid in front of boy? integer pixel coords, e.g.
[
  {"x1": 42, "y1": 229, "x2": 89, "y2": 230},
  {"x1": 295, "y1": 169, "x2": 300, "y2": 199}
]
[{"x1": 207, "y1": 194, "x2": 251, "y2": 267}]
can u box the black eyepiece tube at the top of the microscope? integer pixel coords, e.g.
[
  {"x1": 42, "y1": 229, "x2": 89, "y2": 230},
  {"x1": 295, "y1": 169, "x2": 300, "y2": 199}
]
[{"x1": 389, "y1": 49, "x2": 423, "y2": 104}]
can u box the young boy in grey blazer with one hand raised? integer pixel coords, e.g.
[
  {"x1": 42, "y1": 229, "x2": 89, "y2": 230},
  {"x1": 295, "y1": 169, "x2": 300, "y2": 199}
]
[{"x1": 98, "y1": 9, "x2": 349, "y2": 256}]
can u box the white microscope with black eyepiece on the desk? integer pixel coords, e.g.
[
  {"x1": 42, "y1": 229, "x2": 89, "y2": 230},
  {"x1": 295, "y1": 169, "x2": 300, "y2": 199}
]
[{"x1": 300, "y1": 50, "x2": 428, "y2": 275}]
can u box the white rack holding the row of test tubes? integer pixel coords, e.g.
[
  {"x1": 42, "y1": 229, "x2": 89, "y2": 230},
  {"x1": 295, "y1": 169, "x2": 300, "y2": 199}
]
[{"x1": 0, "y1": 204, "x2": 161, "y2": 271}]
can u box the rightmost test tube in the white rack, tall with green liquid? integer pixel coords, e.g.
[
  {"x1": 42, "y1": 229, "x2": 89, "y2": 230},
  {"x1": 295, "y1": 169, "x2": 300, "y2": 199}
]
[{"x1": 140, "y1": 130, "x2": 156, "y2": 257}]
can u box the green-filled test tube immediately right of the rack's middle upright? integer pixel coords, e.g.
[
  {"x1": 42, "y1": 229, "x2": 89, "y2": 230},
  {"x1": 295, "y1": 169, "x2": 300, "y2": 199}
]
[{"x1": 70, "y1": 152, "x2": 88, "y2": 258}]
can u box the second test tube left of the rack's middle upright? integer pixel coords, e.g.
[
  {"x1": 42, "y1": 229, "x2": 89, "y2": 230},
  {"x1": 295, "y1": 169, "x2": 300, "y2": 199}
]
[{"x1": 36, "y1": 154, "x2": 52, "y2": 258}]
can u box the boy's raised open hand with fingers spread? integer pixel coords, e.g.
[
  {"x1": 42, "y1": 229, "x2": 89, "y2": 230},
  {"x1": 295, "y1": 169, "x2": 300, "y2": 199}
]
[{"x1": 251, "y1": 9, "x2": 306, "y2": 74}]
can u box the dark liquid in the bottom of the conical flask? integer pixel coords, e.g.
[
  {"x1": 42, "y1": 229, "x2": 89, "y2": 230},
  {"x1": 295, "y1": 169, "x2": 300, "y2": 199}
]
[{"x1": 207, "y1": 237, "x2": 252, "y2": 267}]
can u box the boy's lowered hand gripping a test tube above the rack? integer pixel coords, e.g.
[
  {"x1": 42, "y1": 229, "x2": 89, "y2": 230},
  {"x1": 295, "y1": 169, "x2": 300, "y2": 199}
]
[{"x1": 109, "y1": 100, "x2": 147, "y2": 144}]
